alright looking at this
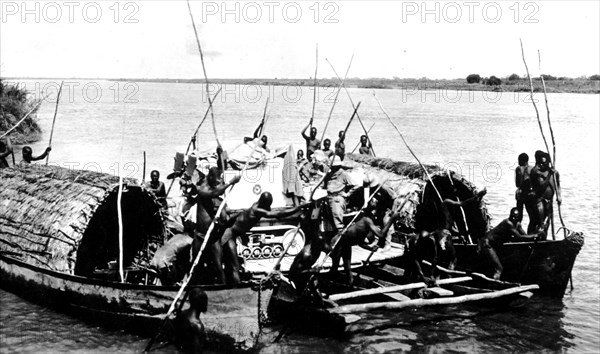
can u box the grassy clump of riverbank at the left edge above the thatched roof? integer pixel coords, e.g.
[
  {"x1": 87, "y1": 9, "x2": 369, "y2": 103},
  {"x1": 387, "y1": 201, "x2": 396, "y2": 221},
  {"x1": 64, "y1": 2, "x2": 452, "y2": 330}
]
[{"x1": 0, "y1": 79, "x2": 42, "y2": 145}]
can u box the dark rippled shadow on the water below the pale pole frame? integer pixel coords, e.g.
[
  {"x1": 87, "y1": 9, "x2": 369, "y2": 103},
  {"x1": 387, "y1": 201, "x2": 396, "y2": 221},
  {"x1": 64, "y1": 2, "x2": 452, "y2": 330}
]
[{"x1": 262, "y1": 297, "x2": 573, "y2": 353}]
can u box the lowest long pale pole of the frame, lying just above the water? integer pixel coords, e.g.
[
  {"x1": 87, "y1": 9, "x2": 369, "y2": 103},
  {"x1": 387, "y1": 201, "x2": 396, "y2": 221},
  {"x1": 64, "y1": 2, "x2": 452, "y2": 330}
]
[{"x1": 327, "y1": 284, "x2": 540, "y2": 314}]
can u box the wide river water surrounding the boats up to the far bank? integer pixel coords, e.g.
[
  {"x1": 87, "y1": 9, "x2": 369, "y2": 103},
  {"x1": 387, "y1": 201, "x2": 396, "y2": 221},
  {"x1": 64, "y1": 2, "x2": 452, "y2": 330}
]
[{"x1": 0, "y1": 80, "x2": 600, "y2": 353}]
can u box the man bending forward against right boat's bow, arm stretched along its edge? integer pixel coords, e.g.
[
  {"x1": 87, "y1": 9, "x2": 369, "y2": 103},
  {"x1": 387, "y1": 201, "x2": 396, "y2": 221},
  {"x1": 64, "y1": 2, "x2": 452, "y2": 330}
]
[{"x1": 477, "y1": 208, "x2": 543, "y2": 280}]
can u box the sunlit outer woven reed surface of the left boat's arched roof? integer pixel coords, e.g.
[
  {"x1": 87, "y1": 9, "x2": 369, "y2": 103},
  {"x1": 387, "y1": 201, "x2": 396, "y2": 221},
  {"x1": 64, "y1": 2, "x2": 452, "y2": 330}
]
[{"x1": 0, "y1": 164, "x2": 164, "y2": 273}]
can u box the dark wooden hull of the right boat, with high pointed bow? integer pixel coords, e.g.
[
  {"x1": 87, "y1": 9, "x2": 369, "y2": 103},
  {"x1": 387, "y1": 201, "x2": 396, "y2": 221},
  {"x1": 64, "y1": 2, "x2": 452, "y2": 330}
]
[{"x1": 454, "y1": 233, "x2": 584, "y2": 298}]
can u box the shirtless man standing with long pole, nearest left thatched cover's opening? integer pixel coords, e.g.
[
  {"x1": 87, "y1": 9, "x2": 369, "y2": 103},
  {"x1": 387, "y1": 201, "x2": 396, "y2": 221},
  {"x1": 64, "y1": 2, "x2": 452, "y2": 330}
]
[{"x1": 192, "y1": 167, "x2": 241, "y2": 284}]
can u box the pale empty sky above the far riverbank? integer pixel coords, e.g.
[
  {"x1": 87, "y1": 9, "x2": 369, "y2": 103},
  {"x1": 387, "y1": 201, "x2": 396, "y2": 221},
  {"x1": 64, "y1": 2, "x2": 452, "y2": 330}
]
[{"x1": 0, "y1": 0, "x2": 600, "y2": 79}]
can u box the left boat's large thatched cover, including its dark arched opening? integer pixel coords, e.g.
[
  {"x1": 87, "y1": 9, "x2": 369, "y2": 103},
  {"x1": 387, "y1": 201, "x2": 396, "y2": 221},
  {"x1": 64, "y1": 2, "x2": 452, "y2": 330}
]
[{"x1": 0, "y1": 164, "x2": 165, "y2": 275}]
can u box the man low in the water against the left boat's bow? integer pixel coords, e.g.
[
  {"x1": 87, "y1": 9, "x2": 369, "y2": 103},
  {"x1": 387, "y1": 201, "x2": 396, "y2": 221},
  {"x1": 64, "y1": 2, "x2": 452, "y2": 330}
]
[{"x1": 174, "y1": 288, "x2": 208, "y2": 353}]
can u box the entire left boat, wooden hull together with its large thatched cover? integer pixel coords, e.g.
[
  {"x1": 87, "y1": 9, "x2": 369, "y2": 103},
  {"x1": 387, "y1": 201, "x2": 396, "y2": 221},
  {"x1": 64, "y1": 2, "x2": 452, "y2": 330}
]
[{"x1": 0, "y1": 165, "x2": 270, "y2": 351}]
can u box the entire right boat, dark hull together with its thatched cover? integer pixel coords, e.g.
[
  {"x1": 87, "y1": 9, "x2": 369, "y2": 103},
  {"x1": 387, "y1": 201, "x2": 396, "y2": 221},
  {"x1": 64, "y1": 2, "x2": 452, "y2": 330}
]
[{"x1": 346, "y1": 155, "x2": 585, "y2": 298}]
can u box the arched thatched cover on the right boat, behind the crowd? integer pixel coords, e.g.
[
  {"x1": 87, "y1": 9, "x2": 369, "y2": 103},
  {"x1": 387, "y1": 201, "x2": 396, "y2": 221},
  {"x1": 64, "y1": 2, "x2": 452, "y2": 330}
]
[{"x1": 344, "y1": 154, "x2": 490, "y2": 237}]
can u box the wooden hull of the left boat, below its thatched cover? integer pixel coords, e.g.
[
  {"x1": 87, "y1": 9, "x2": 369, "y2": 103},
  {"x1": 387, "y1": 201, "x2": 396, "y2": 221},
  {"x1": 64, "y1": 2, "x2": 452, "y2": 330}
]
[{"x1": 0, "y1": 255, "x2": 271, "y2": 351}]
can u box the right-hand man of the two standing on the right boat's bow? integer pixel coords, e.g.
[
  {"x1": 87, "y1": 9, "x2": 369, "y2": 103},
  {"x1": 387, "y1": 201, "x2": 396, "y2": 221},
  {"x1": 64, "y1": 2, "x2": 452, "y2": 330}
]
[{"x1": 527, "y1": 153, "x2": 562, "y2": 234}]
